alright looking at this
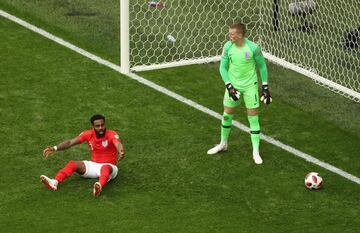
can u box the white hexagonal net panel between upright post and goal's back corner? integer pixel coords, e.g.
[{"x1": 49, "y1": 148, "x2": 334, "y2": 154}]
[{"x1": 130, "y1": 0, "x2": 260, "y2": 66}]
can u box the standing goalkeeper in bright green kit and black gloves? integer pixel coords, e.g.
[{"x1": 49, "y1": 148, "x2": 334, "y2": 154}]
[{"x1": 207, "y1": 23, "x2": 272, "y2": 164}]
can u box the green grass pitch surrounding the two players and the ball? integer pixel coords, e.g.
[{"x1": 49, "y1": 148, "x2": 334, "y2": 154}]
[{"x1": 0, "y1": 1, "x2": 360, "y2": 233}]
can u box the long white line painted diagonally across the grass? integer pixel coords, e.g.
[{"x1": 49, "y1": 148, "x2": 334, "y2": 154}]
[{"x1": 0, "y1": 10, "x2": 360, "y2": 184}]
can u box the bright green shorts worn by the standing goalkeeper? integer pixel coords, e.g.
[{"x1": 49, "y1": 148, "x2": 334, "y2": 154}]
[{"x1": 223, "y1": 85, "x2": 260, "y2": 109}]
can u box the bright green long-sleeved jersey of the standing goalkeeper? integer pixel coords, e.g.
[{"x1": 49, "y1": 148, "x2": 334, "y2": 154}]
[{"x1": 220, "y1": 39, "x2": 268, "y2": 90}]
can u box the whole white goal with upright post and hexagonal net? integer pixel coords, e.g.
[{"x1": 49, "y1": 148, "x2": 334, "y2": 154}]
[{"x1": 120, "y1": 0, "x2": 360, "y2": 102}]
